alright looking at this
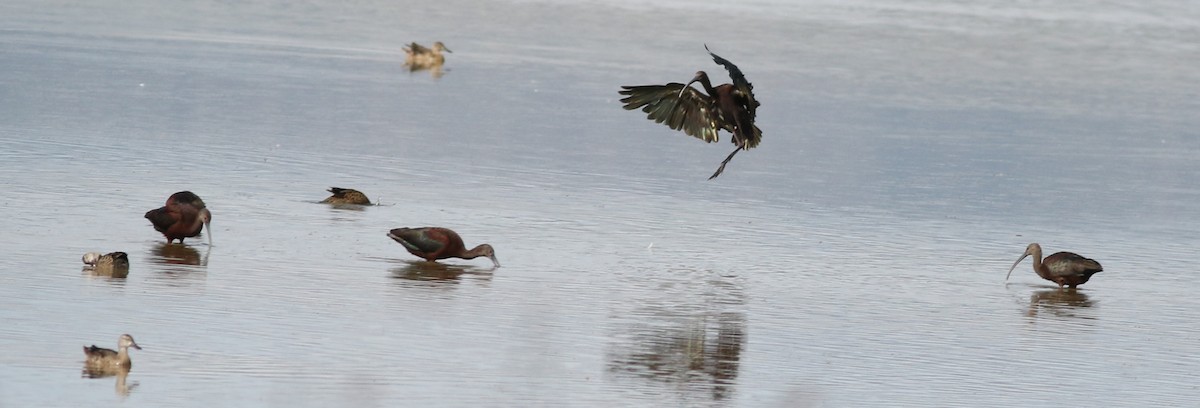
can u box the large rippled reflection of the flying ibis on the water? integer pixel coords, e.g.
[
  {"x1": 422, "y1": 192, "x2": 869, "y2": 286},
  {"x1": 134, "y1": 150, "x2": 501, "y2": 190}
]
[{"x1": 607, "y1": 268, "x2": 746, "y2": 401}]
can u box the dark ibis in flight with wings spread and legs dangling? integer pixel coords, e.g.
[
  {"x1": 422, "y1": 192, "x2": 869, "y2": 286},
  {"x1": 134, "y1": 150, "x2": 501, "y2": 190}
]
[{"x1": 620, "y1": 44, "x2": 762, "y2": 180}]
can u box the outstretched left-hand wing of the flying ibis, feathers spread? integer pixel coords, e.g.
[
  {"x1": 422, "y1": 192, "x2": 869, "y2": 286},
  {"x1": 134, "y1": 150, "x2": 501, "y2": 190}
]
[{"x1": 619, "y1": 83, "x2": 720, "y2": 143}]
